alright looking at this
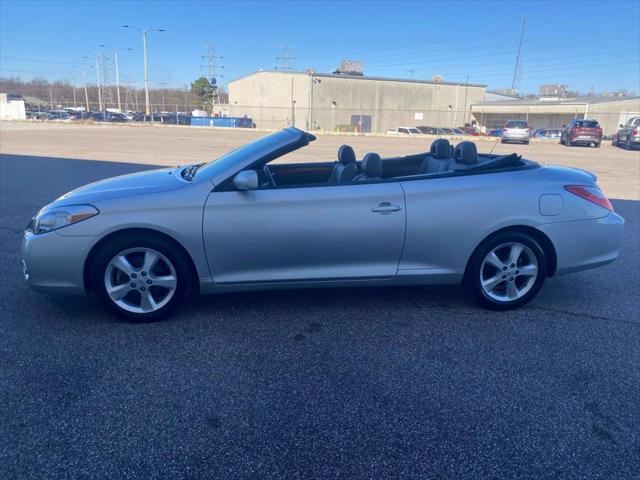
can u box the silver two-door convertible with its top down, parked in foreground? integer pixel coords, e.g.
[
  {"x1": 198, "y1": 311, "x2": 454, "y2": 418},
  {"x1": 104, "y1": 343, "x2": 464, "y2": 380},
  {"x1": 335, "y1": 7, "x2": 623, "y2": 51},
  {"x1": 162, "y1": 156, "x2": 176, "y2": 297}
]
[{"x1": 22, "y1": 128, "x2": 624, "y2": 321}]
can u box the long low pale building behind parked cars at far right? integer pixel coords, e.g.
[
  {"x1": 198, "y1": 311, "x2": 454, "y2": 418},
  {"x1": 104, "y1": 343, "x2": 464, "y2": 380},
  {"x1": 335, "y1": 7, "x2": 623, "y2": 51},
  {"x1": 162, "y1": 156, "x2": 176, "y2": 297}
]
[{"x1": 471, "y1": 97, "x2": 640, "y2": 135}]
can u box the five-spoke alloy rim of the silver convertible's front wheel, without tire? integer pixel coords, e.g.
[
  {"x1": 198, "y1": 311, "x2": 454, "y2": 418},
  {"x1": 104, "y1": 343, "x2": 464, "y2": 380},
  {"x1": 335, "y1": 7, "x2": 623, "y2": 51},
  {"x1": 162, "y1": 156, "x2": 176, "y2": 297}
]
[{"x1": 104, "y1": 247, "x2": 178, "y2": 313}]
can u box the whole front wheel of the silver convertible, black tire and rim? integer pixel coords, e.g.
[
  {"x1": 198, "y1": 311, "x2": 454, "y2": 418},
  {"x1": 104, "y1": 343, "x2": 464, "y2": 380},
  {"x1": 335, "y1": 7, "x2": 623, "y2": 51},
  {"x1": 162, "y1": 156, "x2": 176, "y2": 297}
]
[{"x1": 91, "y1": 233, "x2": 195, "y2": 322}]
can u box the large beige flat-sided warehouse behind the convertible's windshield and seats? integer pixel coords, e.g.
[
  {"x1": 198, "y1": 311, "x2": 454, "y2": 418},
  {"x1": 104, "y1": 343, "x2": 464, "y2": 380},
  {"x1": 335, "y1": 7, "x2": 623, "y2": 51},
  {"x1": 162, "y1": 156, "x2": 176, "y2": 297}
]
[{"x1": 228, "y1": 71, "x2": 486, "y2": 132}]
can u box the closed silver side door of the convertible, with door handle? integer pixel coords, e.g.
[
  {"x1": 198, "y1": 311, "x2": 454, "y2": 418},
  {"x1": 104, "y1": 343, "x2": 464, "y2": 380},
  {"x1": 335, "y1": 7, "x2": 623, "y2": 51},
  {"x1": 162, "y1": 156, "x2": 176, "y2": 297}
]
[{"x1": 203, "y1": 182, "x2": 405, "y2": 284}]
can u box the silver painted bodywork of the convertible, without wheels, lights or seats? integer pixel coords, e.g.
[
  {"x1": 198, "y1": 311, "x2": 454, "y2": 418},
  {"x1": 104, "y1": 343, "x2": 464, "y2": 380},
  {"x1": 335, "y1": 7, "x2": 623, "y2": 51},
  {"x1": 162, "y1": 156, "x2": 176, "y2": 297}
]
[{"x1": 22, "y1": 130, "x2": 624, "y2": 293}]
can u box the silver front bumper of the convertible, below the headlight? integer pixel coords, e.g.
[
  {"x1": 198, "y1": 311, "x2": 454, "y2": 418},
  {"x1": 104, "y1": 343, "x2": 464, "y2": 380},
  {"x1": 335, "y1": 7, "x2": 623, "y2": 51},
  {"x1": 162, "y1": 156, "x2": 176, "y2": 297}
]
[{"x1": 20, "y1": 231, "x2": 94, "y2": 294}]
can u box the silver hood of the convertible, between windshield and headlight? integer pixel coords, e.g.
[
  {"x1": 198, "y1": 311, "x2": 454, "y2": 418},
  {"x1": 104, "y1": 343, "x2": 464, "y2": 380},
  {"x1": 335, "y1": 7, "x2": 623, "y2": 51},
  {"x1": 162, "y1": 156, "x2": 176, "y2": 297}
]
[{"x1": 56, "y1": 167, "x2": 189, "y2": 203}]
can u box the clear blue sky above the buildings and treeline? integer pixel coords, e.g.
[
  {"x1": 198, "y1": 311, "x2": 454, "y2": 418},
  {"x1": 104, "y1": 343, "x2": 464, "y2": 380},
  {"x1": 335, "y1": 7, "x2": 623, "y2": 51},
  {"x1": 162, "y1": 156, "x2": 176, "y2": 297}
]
[{"x1": 0, "y1": 0, "x2": 640, "y2": 94}]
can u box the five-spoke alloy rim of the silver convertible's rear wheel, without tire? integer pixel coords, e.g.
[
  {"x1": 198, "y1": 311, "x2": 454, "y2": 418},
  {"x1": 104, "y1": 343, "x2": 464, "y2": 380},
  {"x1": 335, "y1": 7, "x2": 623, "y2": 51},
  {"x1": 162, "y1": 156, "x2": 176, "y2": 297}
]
[{"x1": 480, "y1": 242, "x2": 538, "y2": 302}]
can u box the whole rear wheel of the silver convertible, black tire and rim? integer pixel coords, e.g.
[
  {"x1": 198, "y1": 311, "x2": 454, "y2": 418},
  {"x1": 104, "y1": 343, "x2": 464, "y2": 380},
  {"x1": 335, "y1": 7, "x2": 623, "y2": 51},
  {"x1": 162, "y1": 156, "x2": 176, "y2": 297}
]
[{"x1": 463, "y1": 232, "x2": 547, "y2": 310}]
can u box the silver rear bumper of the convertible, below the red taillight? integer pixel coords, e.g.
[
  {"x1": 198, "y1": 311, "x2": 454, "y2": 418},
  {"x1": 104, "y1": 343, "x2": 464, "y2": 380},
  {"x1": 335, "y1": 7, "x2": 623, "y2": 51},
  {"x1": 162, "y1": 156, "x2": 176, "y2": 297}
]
[{"x1": 538, "y1": 212, "x2": 624, "y2": 275}]
